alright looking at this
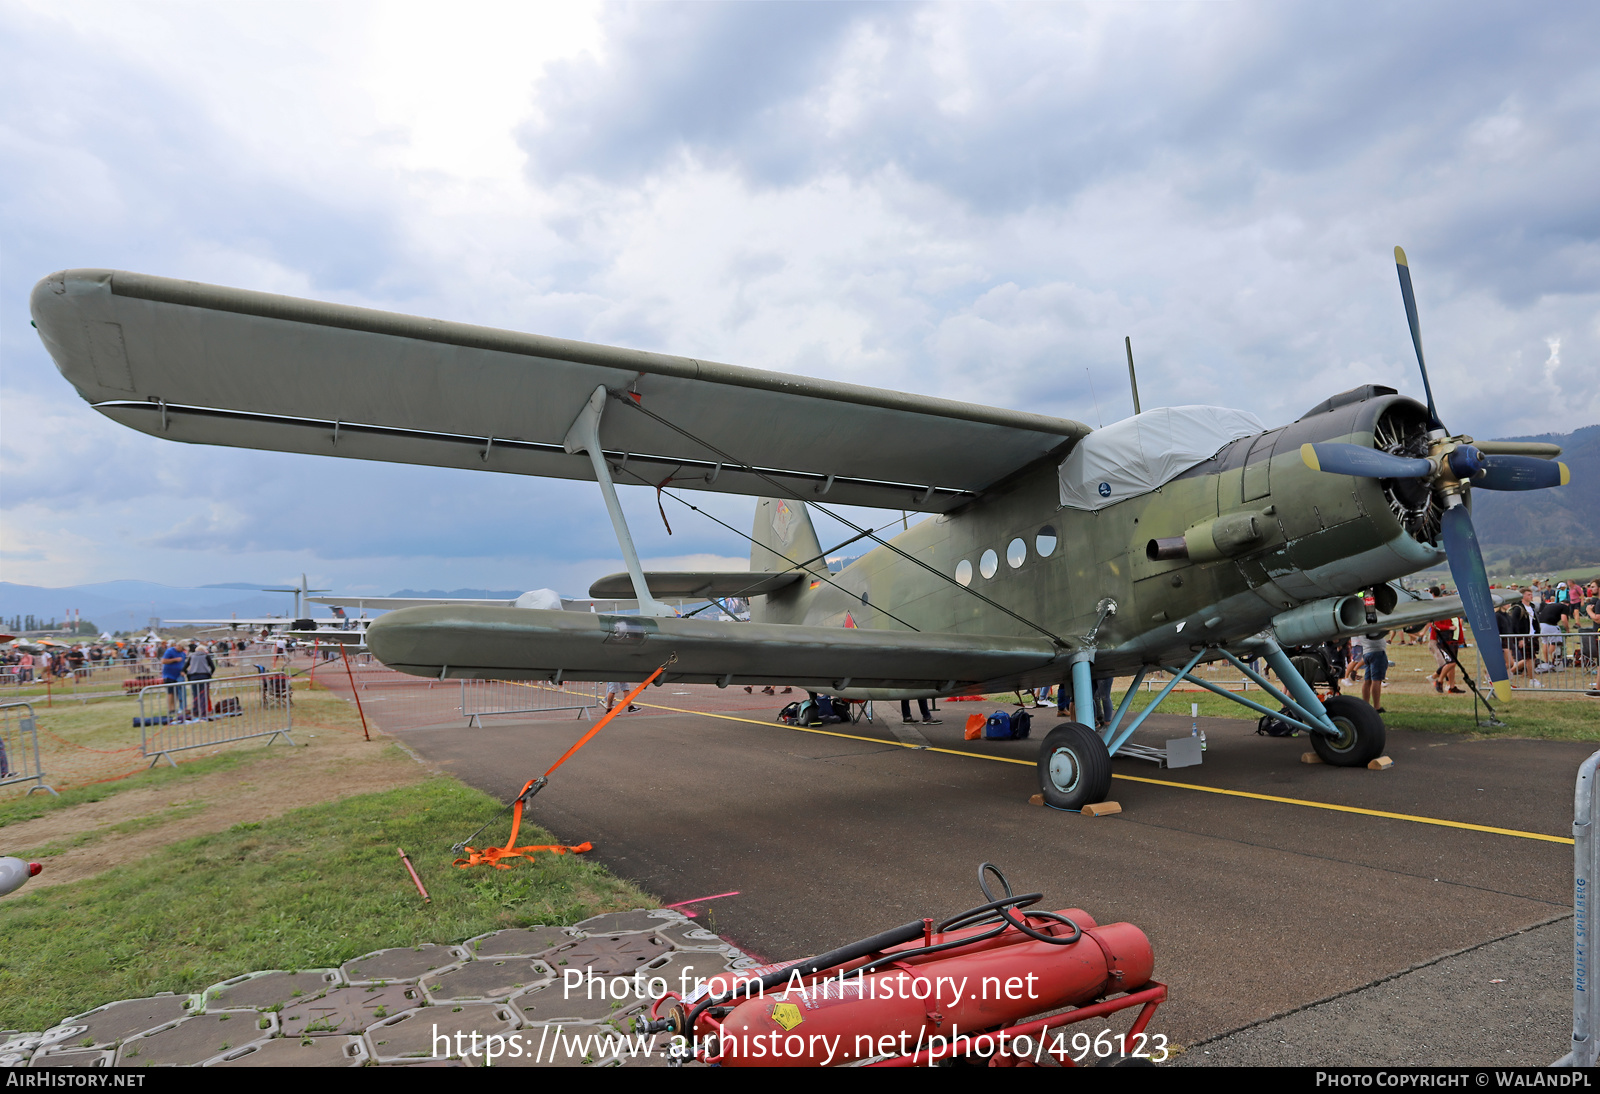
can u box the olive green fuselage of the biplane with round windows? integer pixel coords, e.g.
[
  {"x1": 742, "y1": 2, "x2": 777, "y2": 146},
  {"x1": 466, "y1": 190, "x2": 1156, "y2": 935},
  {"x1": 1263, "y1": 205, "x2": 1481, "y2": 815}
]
[{"x1": 752, "y1": 395, "x2": 1443, "y2": 685}]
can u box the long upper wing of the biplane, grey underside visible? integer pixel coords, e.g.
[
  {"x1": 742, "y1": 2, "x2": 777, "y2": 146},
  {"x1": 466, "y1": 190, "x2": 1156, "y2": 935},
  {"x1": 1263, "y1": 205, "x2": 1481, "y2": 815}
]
[{"x1": 32, "y1": 270, "x2": 1090, "y2": 512}]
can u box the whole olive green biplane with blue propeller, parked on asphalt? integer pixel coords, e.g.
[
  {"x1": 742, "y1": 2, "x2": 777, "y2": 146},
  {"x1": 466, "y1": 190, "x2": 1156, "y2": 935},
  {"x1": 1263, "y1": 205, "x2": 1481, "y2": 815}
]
[{"x1": 32, "y1": 248, "x2": 1568, "y2": 808}]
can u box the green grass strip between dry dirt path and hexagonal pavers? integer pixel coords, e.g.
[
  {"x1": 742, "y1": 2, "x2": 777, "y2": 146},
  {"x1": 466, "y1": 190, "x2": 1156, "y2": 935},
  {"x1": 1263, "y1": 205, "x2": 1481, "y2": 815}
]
[{"x1": 0, "y1": 777, "x2": 654, "y2": 1030}]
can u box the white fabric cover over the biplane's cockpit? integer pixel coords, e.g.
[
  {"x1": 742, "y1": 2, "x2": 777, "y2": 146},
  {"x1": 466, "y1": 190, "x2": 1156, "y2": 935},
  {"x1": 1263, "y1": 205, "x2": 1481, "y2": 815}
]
[{"x1": 1058, "y1": 406, "x2": 1267, "y2": 510}]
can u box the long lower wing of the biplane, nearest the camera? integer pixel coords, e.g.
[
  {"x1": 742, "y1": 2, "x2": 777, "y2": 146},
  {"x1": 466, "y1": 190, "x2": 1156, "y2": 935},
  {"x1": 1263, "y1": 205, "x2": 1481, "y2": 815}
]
[{"x1": 366, "y1": 606, "x2": 1058, "y2": 694}]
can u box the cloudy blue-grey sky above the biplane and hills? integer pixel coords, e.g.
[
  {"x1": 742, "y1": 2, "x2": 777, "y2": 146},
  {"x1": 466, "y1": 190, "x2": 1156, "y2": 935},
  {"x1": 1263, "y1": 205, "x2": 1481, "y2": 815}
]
[{"x1": 0, "y1": 0, "x2": 1600, "y2": 593}]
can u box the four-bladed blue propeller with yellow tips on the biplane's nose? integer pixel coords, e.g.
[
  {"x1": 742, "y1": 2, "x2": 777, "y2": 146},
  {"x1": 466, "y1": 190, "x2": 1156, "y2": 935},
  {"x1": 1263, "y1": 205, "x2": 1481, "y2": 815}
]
[{"x1": 1301, "y1": 246, "x2": 1571, "y2": 699}]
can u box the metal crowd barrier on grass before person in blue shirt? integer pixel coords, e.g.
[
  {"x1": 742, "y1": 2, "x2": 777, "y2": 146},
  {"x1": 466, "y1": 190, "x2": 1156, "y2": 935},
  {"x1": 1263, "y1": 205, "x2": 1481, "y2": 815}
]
[{"x1": 134, "y1": 672, "x2": 294, "y2": 768}]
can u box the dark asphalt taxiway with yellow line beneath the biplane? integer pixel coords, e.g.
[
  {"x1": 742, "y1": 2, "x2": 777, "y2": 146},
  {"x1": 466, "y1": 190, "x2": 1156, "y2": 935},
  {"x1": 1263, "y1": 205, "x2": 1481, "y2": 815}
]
[{"x1": 387, "y1": 685, "x2": 1594, "y2": 1064}]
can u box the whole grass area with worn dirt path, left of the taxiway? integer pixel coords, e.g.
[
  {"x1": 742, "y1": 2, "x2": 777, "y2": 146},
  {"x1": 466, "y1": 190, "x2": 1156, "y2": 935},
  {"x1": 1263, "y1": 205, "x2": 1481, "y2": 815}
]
[{"x1": 0, "y1": 674, "x2": 654, "y2": 1030}]
